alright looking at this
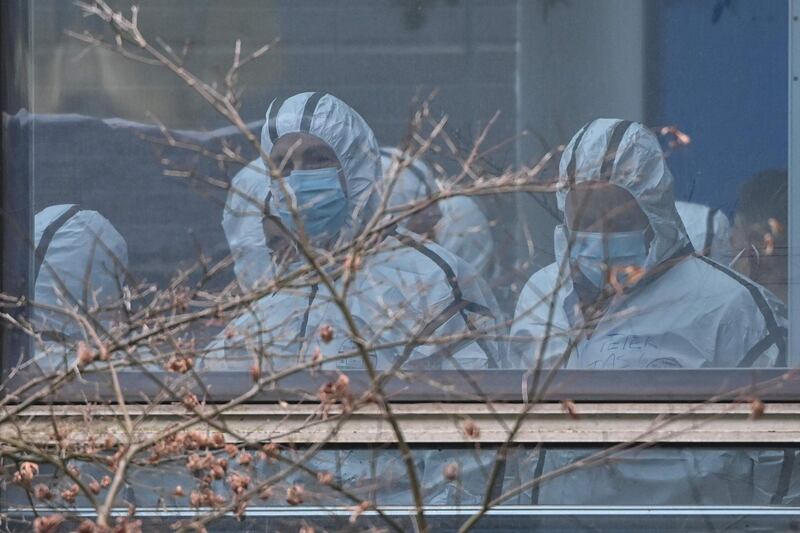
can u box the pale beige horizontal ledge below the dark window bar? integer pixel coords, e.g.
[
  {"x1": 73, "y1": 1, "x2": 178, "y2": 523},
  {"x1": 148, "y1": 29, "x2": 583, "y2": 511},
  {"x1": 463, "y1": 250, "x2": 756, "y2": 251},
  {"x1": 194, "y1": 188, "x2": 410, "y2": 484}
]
[{"x1": 0, "y1": 403, "x2": 800, "y2": 445}]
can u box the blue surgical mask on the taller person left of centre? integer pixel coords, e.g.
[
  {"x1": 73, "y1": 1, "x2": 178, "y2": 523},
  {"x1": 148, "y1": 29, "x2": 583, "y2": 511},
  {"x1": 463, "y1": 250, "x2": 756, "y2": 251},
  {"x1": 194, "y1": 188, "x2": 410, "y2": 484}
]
[{"x1": 276, "y1": 167, "x2": 347, "y2": 241}]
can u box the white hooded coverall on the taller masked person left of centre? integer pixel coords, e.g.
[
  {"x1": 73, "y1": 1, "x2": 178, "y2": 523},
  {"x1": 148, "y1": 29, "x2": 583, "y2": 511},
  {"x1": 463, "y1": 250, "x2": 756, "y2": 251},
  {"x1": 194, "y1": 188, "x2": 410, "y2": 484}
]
[{"x1": 207, "y1": 93, "x2": 502, "y2": 369}]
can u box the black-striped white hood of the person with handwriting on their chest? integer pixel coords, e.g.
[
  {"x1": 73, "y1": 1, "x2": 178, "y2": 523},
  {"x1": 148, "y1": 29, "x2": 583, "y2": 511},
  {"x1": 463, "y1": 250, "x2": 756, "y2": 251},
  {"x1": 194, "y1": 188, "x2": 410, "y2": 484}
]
[{"x1": 556, "y1": 118, "x2": 690, "y2": 268}]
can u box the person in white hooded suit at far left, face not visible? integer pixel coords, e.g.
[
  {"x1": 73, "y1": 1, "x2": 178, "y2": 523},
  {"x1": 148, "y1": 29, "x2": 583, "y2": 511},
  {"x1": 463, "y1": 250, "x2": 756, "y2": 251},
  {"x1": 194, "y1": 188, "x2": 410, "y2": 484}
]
[{"x1": 32, "y1": 204, "x2": 128, "y2": 369}]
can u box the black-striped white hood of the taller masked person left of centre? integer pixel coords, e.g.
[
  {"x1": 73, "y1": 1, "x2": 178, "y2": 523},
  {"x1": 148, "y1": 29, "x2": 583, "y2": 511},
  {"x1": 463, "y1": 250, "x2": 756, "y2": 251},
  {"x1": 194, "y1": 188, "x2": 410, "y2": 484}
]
[{"x1": 261, "y1": 92, "x2": 381, "y2": 240}]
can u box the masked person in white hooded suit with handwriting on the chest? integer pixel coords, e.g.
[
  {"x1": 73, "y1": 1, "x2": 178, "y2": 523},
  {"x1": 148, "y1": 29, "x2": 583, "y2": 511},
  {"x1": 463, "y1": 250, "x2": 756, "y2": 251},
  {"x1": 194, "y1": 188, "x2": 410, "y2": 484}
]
[{"x1": 511, "y1": 119, "x2": 787, "y2": 368}]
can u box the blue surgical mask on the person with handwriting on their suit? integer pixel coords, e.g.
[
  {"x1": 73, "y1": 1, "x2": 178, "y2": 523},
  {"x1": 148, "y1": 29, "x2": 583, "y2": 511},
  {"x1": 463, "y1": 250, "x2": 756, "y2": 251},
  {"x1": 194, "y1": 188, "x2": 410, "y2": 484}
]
[{"x1": 569, "y1": 230, "x2": 647, "y2": 288}]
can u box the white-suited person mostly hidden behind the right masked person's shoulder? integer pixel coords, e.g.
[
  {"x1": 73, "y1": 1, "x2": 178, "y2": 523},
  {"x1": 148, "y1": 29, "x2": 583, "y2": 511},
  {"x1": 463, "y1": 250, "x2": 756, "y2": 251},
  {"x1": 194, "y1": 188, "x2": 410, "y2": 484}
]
[{"x1": 675, "y1": 200, "x2": 733, "y2": 266}]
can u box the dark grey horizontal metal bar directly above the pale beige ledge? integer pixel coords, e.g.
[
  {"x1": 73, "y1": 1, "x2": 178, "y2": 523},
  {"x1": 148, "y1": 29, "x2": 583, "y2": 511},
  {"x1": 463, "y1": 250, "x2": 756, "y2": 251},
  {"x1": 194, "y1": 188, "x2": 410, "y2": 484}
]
[{"x1": 5, "y1": 369, "x2": 800, "y2": 403}]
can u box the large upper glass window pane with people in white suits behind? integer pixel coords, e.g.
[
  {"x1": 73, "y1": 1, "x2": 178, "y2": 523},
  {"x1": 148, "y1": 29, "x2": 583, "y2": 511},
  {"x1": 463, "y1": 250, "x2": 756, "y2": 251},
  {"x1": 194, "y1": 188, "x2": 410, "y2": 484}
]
[{"x1": 3, "y1": 0, "x2": 794, "y2": 394}]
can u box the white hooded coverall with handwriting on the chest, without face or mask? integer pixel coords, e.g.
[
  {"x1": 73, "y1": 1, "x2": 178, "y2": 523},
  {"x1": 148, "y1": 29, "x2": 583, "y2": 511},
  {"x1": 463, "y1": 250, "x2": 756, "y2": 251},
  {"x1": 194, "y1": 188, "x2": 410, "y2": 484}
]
[{"x1": 511, "y1": 119, "x2": 787, "y2": 368}]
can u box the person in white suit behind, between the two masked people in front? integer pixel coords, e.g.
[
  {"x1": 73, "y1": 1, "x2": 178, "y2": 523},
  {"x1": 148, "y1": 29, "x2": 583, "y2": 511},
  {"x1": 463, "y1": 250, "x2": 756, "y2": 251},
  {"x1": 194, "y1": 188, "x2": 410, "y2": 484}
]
[{"x1": 381, "y1": 147, "x2": 494, "y2": 276}]
